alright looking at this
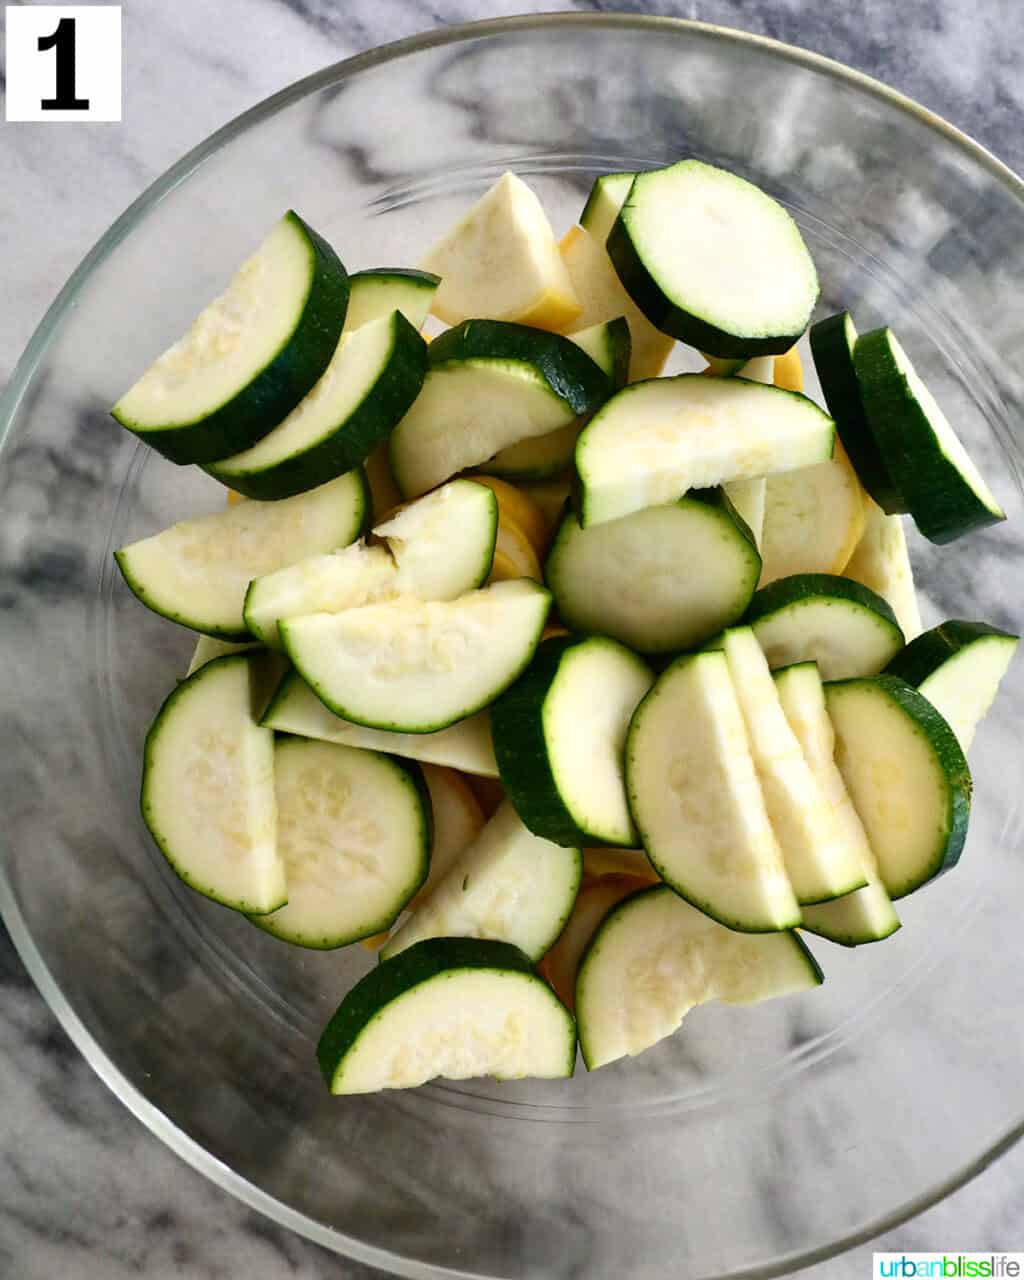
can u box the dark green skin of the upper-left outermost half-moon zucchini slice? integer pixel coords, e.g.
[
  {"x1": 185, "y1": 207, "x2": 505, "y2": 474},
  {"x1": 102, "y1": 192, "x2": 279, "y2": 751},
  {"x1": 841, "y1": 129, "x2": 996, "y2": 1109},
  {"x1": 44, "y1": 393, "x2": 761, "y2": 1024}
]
[{"x1": 111, "y1": 210, "x2": 348, "y2": 468}]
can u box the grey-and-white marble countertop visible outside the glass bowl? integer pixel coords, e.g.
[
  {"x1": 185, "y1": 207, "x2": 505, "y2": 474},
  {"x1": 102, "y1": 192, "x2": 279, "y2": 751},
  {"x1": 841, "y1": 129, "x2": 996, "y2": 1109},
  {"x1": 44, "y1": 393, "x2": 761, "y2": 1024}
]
[{"x1": 0, "y1": 0, "x2": 1024, "y2": 1280}]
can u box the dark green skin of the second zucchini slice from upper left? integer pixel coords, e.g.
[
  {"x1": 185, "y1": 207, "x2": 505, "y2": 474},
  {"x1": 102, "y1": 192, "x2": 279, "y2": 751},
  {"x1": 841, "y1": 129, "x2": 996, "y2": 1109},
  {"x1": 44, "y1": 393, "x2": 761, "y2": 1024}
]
[{"x1": 205, "y1": 311, "x2": 426, "y2": 502}]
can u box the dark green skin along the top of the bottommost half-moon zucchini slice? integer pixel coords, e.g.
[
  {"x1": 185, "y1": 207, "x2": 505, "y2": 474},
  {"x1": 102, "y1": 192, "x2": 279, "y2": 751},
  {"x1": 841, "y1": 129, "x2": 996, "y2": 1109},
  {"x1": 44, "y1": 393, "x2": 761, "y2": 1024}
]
[{"x1": 316, "y1": 938, "x2": 563, "y2": 1085}]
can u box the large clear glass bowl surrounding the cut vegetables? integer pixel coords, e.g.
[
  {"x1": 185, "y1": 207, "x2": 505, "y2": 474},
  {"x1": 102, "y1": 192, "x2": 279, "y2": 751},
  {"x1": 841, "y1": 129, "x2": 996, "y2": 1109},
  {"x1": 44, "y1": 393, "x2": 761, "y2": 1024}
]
[{"x1": 0, "y1": 15, "x2": 1024, "y2": 1280}]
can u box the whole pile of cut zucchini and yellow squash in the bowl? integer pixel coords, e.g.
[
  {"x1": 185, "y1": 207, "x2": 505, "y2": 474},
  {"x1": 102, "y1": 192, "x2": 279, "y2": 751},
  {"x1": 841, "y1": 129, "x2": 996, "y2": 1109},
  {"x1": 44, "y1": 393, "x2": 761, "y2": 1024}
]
[{"x1": 114, "y1": 160, "x2": 1018, "y2": 1093}]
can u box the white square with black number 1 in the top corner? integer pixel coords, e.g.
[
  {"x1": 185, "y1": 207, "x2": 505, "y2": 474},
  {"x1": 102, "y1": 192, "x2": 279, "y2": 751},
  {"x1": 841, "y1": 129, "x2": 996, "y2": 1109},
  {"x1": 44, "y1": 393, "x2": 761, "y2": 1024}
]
[{"x1": 4, "y1": 5, "x2": 120, "y2": 123}]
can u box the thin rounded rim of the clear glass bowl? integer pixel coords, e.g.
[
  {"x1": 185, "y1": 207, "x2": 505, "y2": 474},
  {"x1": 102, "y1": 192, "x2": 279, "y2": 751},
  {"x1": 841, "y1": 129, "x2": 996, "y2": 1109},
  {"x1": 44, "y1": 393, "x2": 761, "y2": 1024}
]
[{"x1": 0, "y1": 12, "x2": 1024, "y2": 1280}]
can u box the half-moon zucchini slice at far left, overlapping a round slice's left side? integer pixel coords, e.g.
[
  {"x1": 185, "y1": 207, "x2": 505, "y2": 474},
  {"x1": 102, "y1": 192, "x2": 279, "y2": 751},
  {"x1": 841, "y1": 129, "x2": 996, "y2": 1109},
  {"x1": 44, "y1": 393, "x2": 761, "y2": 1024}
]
[{"x1": 142, "y1": 654, "x2": 288, "y2": 914}]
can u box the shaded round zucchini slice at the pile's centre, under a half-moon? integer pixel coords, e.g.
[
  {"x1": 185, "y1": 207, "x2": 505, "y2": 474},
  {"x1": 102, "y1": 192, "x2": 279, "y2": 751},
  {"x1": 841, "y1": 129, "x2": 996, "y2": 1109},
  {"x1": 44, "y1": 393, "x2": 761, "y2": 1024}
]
[{"x1": 544, "y1": 489, "x2": 760, "y2": 654}]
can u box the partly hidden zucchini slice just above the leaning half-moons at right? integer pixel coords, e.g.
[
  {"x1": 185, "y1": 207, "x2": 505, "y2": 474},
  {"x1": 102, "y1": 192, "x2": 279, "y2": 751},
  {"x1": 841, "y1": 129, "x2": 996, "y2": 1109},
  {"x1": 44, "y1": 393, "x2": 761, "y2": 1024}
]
[{"x1": 745, "y1": 573, "x2": 904, "y2": 680}]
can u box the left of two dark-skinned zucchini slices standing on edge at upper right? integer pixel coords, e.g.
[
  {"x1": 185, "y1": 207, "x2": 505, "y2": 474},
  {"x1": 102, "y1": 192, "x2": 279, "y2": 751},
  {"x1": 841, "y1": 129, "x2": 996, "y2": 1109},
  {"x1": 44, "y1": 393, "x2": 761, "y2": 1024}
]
[{"x1": 810, "y1": 311, "x2": 906, "y2": 513}]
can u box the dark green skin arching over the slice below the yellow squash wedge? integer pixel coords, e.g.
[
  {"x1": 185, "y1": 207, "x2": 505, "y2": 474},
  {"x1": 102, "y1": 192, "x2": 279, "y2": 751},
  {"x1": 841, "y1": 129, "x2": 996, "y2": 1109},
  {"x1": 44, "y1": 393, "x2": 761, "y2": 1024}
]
[{"x1": 428, "y1": 320, "x2": 612, "y2": 415}]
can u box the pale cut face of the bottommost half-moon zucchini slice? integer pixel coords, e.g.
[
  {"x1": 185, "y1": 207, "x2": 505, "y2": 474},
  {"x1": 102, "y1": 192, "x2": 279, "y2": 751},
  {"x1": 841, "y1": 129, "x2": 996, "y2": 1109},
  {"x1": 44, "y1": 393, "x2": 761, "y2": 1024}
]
[{"x1": 332, "y1": 969, "x2": 575, "y2": 1093}]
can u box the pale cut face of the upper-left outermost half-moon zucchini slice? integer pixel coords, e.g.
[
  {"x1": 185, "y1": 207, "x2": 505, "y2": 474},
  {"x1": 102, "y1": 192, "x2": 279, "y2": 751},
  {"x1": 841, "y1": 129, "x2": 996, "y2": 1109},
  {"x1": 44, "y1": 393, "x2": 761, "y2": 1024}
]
[{"x1": 114, "y1": 216, "x2": 314, "y2": 431}]
